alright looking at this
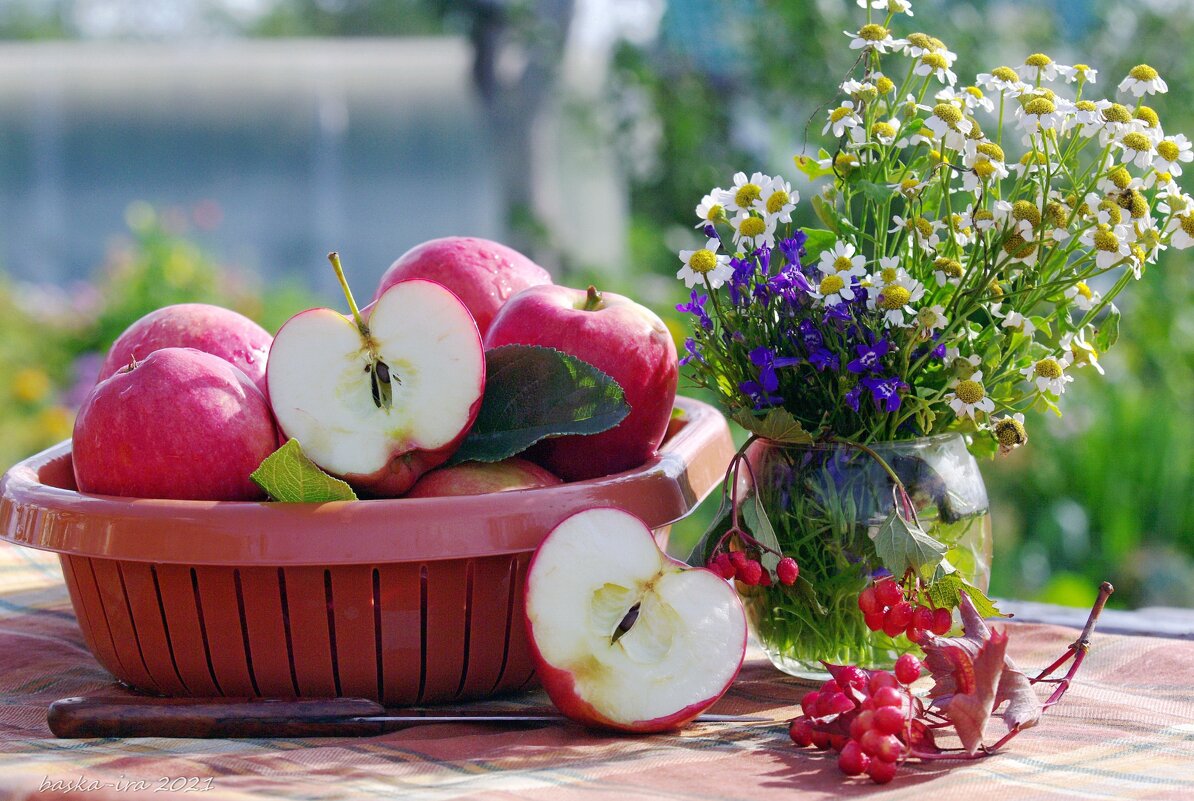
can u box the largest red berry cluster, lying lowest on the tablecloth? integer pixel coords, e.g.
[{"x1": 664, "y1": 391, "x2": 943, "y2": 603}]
[{"x1": 788, "y1": 654, "x2": 933, "y2": 784}]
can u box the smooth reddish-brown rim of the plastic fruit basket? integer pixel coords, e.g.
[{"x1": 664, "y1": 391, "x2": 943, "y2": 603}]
[{"x1": 0, "y1": 396, "x2": 734, "y2": 566}]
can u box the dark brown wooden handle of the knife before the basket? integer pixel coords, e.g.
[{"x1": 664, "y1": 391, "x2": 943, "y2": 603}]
[{"x1": 48, "y1": 696, "x2": 386, "y2": 739}]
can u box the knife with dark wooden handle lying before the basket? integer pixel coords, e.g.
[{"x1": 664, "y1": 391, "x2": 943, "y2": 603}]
[{"x1": 47, "y1": 696, "x2": 775, "y2": 739}]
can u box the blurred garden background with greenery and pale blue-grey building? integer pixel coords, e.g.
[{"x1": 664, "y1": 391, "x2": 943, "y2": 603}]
[{"x1": 0, "y1": 0, "x2": 1194, "y2": 606}]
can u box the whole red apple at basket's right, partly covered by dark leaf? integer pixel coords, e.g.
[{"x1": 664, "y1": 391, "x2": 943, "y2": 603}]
[{"x1": 485, "y1": 285, "x2": 679, "y2": 481}]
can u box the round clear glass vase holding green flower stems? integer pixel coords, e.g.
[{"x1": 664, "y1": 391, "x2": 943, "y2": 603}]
[{"x1": 738, "y1": 433, "x2": 991, "y2": 678}]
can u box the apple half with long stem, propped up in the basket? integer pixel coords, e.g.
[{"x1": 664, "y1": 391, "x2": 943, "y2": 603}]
[{"x1": 266, "y1": 254, "x2": 485, "y2": 497}]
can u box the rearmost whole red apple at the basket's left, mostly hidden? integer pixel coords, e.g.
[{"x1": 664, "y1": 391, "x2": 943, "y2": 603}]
[{"x1": 97, "y1": 303, "x2": 273, "y2": 393}]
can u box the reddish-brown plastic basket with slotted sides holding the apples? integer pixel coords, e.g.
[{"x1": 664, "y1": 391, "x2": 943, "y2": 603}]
[{"x1": 0, "y1": 399, "x2": 734, "y2": 706}]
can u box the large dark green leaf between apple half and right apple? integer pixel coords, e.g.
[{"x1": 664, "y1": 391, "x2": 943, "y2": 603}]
[{"x1": 451, "y1": 345, "x2": 630, "y2": 464}]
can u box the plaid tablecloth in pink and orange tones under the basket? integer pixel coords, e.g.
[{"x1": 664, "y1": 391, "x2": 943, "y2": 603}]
[{"x1": 0, "y1": 543, "x2": 1194, "y2": 801}]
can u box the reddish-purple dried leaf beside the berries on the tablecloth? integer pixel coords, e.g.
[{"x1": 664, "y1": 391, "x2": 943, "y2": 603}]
[{"x1": 921, "y1": 593, "x2": 1042, "y2": 747}]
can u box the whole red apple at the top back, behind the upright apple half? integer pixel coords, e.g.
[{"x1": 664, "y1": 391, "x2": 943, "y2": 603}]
[{"x1": 374, "y1": 236, "x2": 552, "y2": 337}]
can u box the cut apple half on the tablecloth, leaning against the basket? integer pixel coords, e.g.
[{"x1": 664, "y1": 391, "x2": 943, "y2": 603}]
[{"x1": 525, "y1": 509, "x2": 746, "y2": 733}]
